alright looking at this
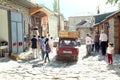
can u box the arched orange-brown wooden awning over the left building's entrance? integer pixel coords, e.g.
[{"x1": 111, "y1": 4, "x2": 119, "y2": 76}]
[{"x1": 29, "y1": 7, "x2": 51, "y2": 16}]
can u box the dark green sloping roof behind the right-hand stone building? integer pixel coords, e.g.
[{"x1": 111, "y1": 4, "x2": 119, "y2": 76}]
[{"x1": 94, "y1": 12, "x2": 114, "y2": 24}]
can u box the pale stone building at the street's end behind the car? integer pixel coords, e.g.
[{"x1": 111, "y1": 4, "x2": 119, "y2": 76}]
[{"x1": 69, "y1": 16, "x2": 95, "y2": 43}]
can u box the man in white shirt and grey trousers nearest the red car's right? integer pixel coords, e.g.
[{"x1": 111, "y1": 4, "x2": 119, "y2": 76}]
[{"x1": 85, "y1": 34, "x2": 92, "y2": 55}]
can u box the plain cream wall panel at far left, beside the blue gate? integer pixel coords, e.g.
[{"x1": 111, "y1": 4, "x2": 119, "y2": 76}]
[{"x1": 0, "y1": 9, "x2": 8, "y2": 42}]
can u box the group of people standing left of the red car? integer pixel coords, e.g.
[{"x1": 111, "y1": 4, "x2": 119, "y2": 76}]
[{"x1": 31, "y1": 35, "x2": 53, "y2": 63}]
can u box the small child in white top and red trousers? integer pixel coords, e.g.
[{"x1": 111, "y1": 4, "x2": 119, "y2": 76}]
[{"x1": 106, "y1": 42, "x2": 114, "y2": 64}]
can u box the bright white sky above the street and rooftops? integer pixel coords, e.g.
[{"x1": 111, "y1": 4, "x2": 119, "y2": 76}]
[{"x1": 36, "y1": 0, "x2": 118, "y2": 19}]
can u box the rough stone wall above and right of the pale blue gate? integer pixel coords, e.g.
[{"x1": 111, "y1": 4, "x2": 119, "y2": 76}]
[{"x1": 0, "y1": 0, "x2": 30, "y2": 34}]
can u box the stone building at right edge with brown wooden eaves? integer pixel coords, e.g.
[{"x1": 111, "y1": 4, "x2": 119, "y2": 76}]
[{"x1": 94, "y1": 11, "x2": 120, "y2": 53}]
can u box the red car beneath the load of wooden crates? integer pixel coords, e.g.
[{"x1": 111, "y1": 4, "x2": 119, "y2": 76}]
[{"x1": 56, "y1": 38, "x2": 79, "y2": 60}]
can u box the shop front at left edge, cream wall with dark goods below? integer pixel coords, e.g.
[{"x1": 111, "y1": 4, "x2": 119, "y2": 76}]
[{"x1": 0, "y1": 9, "x2": 9, "y2": 57}]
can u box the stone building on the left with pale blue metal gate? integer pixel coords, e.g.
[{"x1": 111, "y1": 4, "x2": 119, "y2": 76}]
[{"x1": 0, "y1": 0, "x2": 50, "y2": 54}]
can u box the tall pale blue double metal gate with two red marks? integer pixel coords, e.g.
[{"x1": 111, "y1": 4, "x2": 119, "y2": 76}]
[{"x1": 11, "y1": 12, "x2": 23, "y2": 54}]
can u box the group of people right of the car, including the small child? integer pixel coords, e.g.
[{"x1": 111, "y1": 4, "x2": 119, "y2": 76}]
[{"x1": 85, "y1": 30, "x2": 114, "y2": 64}]
